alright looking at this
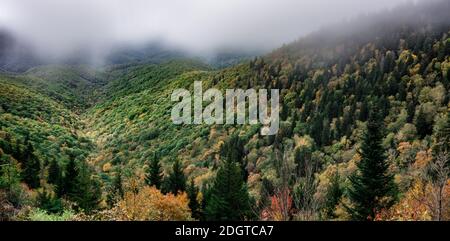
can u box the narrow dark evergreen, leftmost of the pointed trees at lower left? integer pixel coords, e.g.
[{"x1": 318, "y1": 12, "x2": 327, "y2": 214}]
[{"x1": 23, "y1": 140, "x2": 41, "y2": 189}]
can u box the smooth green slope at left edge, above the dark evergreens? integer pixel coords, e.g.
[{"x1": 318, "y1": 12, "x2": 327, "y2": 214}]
[{"x1": 0, "y1": 77, "x2": 92, "y2": 163}]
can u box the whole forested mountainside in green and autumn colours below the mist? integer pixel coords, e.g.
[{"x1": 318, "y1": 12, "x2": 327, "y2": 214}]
[{"x1": 0, "y1": 1, "x2": 450, "y2": 220}]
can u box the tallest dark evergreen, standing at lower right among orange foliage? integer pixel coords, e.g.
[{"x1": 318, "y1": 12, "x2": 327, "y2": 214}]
[{"x1": 347, "y1": 111, "x2": 396, "y2": 220}]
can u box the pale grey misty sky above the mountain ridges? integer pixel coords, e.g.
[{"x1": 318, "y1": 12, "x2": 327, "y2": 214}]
[{"x1": 0, "y1": 0, "x2": 422, "y2": 59}]
